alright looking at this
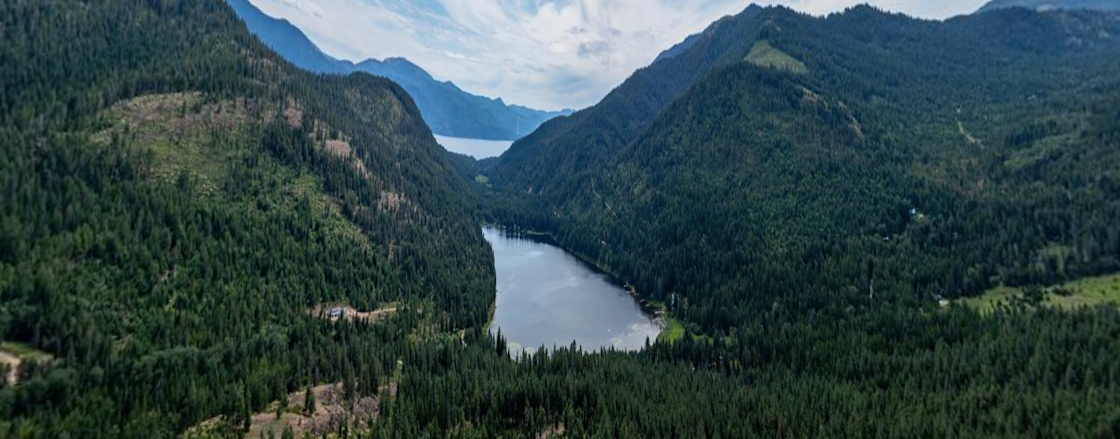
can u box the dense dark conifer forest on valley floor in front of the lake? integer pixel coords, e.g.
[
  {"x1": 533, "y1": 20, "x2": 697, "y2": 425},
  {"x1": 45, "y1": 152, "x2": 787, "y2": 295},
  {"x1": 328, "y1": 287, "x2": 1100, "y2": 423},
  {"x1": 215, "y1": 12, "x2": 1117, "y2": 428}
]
[{"x1": 371, "y1": 315, "x2": 1120, "y2": 438}]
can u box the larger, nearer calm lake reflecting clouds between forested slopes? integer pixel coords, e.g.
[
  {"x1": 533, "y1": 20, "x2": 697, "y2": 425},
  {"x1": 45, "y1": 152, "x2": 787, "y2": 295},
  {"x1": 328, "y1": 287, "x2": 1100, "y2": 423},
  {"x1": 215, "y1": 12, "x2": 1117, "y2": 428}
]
[{"x1": 483, "y1": 227, "x2": 661, "y2": 353}]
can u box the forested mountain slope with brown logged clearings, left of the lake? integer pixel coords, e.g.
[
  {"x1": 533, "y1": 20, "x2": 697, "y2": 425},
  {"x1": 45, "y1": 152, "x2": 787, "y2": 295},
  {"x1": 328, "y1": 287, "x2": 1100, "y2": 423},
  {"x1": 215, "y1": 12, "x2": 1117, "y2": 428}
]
[{"x1": 0, "y1": 0, "x2": 494, "y2": 438}]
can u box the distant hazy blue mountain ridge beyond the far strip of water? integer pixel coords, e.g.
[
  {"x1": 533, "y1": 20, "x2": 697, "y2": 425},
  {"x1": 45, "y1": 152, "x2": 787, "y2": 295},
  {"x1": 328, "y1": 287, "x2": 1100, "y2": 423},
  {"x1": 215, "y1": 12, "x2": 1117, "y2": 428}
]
[{"x1": 227, "y1": 0, "x2": 571, "y2": 140}]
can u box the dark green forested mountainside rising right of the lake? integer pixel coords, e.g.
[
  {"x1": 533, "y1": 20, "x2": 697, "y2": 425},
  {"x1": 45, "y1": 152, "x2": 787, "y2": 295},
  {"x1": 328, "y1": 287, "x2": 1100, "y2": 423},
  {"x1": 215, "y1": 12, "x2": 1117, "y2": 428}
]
[{"x1": 489, "y1": 7, "x2": 1120, "y2": 331}]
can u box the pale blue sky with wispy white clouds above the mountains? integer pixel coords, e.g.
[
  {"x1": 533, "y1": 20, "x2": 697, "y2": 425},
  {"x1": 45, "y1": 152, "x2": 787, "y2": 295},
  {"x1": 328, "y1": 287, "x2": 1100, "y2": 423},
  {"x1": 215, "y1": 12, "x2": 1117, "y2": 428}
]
[{"x1": 250, "y1": 0, "x2": 987, "y2": 110}]
